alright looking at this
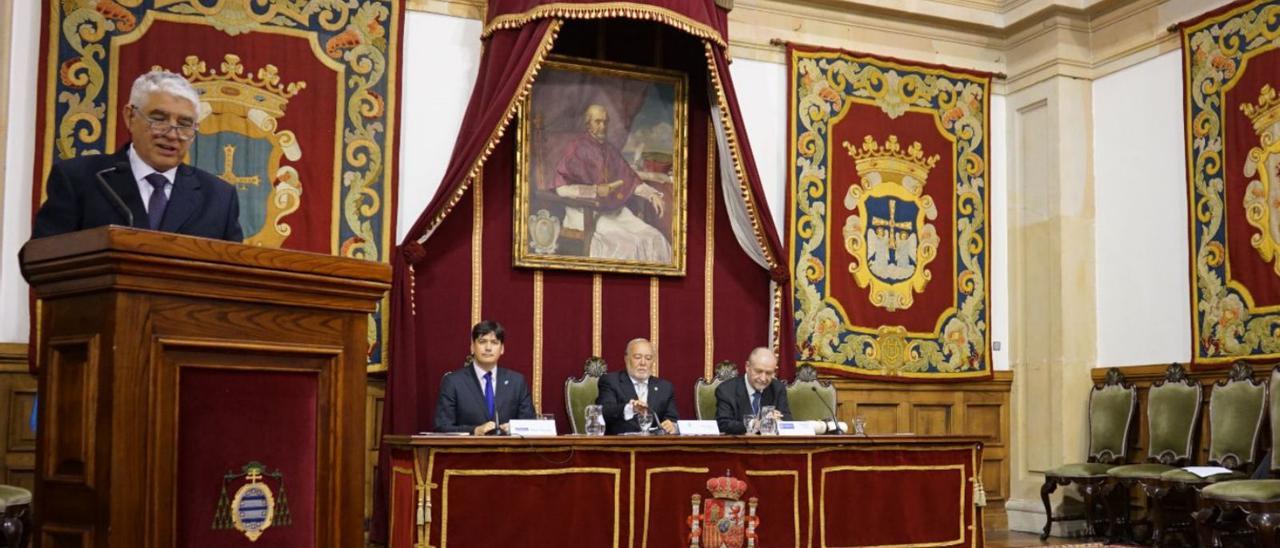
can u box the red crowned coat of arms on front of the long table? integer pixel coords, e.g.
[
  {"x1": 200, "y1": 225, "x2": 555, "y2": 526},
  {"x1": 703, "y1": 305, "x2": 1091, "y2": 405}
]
[{"x1": 687, "y1": 474, "x2": 760, "y2": 548}]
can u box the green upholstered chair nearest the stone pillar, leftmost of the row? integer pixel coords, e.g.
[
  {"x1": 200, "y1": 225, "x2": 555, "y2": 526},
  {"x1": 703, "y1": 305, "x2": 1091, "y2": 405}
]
[{"x1": 1041, "y1": 367, "x2": 1138, "y2": 540}]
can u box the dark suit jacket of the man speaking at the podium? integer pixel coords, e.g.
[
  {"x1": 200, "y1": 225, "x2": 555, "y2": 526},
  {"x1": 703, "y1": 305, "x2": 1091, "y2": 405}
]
[{"x1": 31, "y1": 145, "x2": 244, "y2": 242}]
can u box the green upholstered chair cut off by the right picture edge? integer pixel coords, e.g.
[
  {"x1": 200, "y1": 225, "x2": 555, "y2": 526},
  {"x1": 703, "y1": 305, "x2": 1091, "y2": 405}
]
[{"x1": 1194, "y1": 365, "x2": 1280, "y2": 547}]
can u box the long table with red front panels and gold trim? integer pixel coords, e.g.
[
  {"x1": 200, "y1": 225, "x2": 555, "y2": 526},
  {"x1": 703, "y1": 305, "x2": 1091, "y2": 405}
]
[{"x1": 384, "y1": 435, "x2": 983, "y2": 548}]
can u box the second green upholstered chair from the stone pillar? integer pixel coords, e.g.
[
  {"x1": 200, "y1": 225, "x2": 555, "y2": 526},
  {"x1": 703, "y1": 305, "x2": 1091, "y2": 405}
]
[{"x1": 1105, "y1": 364, "x2": 1203, "y2": 539}]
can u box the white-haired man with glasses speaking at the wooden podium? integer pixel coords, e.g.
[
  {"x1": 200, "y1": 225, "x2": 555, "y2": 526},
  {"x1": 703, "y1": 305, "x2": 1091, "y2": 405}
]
[{"x1": 32, "y1": 72, "x2": 244, "y2": 242}]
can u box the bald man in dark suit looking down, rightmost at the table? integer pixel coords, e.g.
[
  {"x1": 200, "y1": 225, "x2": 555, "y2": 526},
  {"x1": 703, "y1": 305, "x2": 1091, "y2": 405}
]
[{"x1": 716, "y1": 347, "x2": 791, "y2": 434}]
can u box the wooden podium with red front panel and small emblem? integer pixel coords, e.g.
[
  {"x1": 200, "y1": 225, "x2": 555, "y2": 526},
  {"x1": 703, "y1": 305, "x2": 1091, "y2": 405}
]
[{"x1": 20, "y1": 227, "x2": 390, "y2": 548}]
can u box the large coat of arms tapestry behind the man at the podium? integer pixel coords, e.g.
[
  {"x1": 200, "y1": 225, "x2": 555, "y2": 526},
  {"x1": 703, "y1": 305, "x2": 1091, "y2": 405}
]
[{"x1": 33, "y1": 0, "x2": 403, "y2": 369}]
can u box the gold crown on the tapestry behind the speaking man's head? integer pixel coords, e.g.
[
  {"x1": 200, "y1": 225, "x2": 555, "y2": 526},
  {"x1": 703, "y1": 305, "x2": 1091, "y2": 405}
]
[{"x1": 168, "y1": 54, "x2": 307, "y2": 118}]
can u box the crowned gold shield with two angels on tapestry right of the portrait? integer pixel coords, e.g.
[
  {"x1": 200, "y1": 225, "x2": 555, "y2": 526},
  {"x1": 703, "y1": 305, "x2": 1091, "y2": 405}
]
[{"x1": 842, "y1": 136, "x2": 940, "y2": 312}]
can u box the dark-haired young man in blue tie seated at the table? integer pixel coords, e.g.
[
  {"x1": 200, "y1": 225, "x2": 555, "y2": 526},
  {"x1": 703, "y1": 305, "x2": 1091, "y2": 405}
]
[{"x1": 435, "y1": 320, "x2": 534, "y2": 435}]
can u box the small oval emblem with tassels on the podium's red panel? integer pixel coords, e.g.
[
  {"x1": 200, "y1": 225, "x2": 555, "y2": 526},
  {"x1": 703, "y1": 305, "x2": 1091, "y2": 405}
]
[{"x1": 214, "y1": 461, "x2": 293, "y2": 542}]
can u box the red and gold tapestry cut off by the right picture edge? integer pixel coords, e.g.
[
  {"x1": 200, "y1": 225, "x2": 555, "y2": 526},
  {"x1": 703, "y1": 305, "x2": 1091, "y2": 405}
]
[{"x1": 1180, "y1": 0, "x2": 1280, "y2": 365}]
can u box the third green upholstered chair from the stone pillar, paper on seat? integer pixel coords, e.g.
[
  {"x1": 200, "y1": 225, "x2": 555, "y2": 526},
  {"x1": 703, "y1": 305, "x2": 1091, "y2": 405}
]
[{"x1": 1140, "y1": 361, "x2": 1267, "y2": 545}]
